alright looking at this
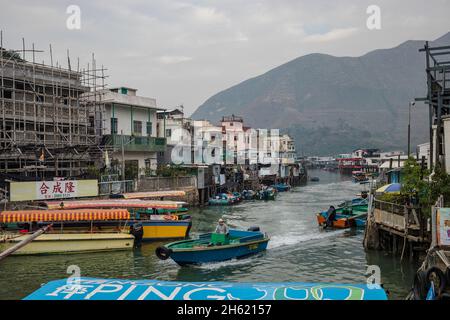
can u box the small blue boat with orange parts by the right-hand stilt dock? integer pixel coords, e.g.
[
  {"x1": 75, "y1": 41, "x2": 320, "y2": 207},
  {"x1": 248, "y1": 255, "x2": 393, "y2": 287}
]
[{"x1": 316, "y1": 207, "x2": 367, "y2": 229}]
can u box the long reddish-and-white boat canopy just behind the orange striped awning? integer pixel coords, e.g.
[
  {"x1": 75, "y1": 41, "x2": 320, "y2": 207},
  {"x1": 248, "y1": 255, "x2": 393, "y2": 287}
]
[{"x1": 44, "y1": 199, "x2": 185, "y2": 209}]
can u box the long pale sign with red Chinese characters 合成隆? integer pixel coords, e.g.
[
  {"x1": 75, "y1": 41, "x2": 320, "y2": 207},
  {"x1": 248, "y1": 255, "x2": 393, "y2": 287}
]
[{"x1": 10, "y1": 180, "x2": 98, "y2": 201}]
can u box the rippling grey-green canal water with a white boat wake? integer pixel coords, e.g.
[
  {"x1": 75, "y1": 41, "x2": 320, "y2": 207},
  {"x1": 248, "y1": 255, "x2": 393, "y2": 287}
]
[{"x1": 0, "y1": 171, "x2": 419, "y2": 299}]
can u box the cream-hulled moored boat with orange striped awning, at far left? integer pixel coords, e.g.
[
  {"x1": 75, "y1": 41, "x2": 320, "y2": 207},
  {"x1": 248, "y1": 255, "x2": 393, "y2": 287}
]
[{"x1": 0, "y1": 209, "x2": 134, "y2": 255}]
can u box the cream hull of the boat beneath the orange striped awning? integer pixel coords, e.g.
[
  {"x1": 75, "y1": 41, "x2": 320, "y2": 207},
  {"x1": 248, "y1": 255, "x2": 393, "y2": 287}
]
[{"x1": 0, "y1": 233, "x2": 134, "y2": 255}]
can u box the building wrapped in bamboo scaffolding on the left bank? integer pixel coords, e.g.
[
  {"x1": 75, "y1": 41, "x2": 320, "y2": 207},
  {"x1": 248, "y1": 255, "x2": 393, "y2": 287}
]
[{"x1": 0, "y1": 34, "x2": 105, "y2": 180}]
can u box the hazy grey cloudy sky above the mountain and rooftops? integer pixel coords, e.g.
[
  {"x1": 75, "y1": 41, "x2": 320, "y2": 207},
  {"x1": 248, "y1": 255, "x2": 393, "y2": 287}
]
[{"x1": 0, "y1": 0, "x2": 450, "y2": 114}]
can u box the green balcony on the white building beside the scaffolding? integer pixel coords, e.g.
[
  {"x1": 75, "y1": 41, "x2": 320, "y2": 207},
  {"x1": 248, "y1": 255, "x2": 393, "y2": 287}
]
[{"x1": 103, "y1": 134, "x2": 167, "y2": 152}]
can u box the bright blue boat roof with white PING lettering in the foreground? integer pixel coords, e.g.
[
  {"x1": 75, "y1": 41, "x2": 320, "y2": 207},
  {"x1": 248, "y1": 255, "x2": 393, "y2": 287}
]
[{"x1": 25, "y1": 277, "x2": 387, "y2": 300}]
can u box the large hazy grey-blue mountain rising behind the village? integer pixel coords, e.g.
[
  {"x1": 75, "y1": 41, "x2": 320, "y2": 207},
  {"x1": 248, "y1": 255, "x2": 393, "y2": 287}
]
[{"x1": 192, "y1": 32, "x2": 450, "y2": 155}]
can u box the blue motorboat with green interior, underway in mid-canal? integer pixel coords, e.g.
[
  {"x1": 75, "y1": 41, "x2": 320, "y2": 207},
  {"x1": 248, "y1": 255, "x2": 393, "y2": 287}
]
[{"x1": 155, "y1": 227, "x2": 269, "y2": 265}]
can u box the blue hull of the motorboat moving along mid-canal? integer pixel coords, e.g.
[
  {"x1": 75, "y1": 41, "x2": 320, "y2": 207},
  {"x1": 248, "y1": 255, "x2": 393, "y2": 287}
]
[{"x1": 170, "y1": 238, "x2": 269, "y2": 266}]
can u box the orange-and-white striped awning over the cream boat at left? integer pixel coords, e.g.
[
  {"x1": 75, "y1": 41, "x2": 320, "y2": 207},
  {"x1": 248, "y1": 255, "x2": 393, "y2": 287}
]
[{"x1": 0, "y1": 209, "x2": 130, "y2": 223}]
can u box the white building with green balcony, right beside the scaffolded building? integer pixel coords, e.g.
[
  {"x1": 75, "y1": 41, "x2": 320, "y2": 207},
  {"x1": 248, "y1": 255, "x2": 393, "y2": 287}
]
[{"x1": 100, "y1": 87, "x2": 166, "y2": 179}]
